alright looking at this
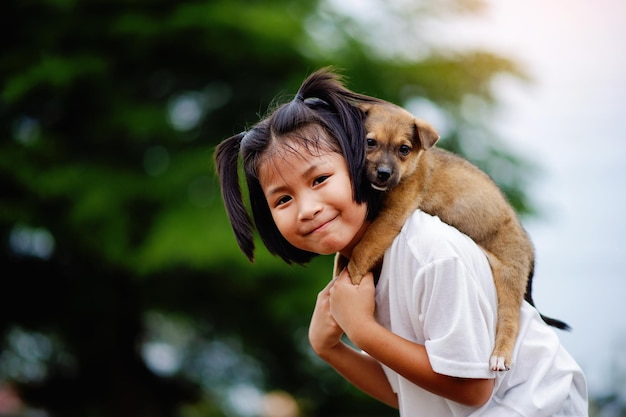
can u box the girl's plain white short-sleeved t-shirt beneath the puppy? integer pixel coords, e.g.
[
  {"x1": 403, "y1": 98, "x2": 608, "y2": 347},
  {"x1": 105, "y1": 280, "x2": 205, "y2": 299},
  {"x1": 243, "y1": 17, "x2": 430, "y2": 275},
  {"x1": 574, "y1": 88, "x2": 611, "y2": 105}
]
[{"x1": 376, "y1": 210, "x2": 588, "y2": 417}]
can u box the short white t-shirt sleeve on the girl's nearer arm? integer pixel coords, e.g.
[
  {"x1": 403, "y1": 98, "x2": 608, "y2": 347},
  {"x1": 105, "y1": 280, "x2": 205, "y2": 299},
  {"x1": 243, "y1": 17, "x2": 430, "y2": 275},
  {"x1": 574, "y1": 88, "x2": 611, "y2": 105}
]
[{"x1": 413, "y1": 258, "x2": 496, "y2": 378}]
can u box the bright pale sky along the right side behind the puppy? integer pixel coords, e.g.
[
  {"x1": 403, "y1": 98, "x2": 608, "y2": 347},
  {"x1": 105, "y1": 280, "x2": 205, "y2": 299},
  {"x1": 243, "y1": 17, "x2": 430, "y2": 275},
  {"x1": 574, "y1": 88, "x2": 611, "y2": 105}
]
[{"x1": 434, "y1": 0, "x2": 626, "y2": 395}]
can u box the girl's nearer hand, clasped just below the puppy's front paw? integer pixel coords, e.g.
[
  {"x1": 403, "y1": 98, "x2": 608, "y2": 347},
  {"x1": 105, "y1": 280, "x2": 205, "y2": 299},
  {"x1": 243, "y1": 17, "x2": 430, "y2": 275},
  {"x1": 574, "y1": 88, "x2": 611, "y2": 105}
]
[{"x1": 330, "y1": 269, "x2": 376, "y2": 346}]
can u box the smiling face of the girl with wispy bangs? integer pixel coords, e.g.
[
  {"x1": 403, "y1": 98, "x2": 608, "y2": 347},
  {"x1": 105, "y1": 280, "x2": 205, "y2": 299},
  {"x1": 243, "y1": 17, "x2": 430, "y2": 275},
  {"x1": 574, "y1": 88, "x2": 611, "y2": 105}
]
[{"x1": 259, "y1": 135, "x2": 367, "y2": 258}]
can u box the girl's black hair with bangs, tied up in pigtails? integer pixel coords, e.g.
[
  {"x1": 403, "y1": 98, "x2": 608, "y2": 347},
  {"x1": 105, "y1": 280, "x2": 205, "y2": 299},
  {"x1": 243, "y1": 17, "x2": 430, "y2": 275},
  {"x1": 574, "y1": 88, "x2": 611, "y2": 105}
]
[{"x1": 215, "y1": 68, "x2": 380, "y2": 264}]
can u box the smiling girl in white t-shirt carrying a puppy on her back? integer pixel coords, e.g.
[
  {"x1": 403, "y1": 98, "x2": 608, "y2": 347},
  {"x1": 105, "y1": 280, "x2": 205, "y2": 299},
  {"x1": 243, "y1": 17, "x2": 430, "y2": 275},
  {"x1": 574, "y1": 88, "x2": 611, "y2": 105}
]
[{"x1": 216, "y1": 70, "x2": 587, "y2": 417}]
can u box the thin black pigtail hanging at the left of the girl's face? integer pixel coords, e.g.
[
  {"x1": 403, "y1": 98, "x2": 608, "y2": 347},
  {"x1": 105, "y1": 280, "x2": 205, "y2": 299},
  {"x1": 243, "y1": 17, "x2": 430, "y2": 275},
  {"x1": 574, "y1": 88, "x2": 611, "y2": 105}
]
[{"x1": 215, "y1": 132, "x2": 254, "y2": 262}]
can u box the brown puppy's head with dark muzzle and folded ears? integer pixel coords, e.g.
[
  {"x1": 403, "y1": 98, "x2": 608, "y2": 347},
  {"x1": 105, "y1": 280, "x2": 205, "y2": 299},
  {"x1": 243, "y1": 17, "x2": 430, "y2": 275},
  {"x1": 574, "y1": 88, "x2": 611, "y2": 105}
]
[{"x1": 360, "y1": 103, "x2": 439, "y2": 191}]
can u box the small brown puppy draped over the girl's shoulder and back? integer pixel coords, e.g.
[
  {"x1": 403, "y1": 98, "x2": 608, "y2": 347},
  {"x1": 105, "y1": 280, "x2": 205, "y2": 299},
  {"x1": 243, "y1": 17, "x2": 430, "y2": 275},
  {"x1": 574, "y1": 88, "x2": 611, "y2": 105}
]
[{"x1": 342, "y1": 102, "x2": 534, "y2": 371}]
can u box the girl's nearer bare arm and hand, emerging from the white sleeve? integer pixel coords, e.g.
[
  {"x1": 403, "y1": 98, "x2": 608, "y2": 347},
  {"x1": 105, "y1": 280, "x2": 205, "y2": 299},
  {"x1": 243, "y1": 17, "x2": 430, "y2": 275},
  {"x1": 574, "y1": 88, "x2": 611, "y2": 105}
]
[{"x1": 330, "y1": 271, "x2": 494, "y2": 407}]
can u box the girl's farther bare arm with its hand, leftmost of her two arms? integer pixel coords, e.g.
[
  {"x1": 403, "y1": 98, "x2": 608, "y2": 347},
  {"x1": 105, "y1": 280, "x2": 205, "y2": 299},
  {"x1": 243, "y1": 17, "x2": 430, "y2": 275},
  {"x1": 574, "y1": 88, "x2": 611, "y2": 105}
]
[{"x1": 309, "y1": 280, "x2": 398, "y2": 408}]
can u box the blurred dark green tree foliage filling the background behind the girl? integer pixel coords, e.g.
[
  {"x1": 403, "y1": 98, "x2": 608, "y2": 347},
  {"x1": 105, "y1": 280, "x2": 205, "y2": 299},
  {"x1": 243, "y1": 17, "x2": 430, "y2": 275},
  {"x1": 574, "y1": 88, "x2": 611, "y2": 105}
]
[{"x1": 0, "y1": 0, "x2": 531, "y2": 417}]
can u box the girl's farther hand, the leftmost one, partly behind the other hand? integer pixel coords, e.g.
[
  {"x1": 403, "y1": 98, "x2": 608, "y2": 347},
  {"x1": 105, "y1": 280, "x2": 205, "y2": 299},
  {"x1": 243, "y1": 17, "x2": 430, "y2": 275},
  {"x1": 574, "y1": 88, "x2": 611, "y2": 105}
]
[{"x1": 309, "y1": 278, "x2": 343, "y2": 357}]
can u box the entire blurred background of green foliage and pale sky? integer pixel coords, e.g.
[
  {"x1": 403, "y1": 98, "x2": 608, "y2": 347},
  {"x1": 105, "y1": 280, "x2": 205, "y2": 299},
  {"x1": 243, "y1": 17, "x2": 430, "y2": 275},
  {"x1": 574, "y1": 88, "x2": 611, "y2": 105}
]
[{"x1": 0, "y1": 0, "x2": 626, "y2": 417}]
